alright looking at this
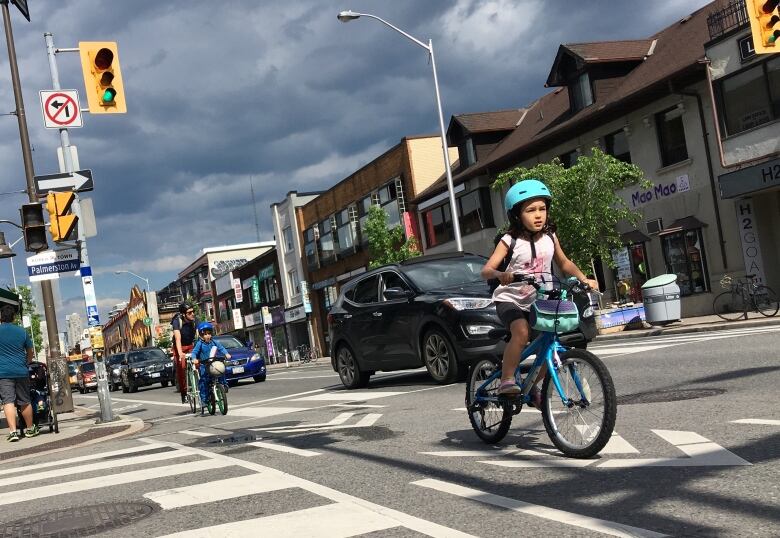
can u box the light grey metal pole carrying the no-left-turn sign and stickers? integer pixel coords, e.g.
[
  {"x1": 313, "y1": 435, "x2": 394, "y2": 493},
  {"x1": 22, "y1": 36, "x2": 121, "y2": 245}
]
[{"x1": 43, "y1": 32, "x2": 114, "y2": 422}]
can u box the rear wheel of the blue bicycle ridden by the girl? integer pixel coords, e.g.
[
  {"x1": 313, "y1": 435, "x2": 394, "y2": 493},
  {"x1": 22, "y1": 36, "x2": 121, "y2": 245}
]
[{"x1": 466, "y1": 359, "x2": 512, "y2": 444}]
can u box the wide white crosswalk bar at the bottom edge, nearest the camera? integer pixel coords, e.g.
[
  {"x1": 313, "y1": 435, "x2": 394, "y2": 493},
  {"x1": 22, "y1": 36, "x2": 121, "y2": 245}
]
[{"x1": 161, "y1": 503, "x2": 400, "y2": 538}]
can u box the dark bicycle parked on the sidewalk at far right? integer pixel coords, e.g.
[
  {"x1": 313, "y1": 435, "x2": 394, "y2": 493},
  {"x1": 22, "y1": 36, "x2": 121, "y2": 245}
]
[{"x1": 712, "y1": 275, "x2": 780, "y2": 321}]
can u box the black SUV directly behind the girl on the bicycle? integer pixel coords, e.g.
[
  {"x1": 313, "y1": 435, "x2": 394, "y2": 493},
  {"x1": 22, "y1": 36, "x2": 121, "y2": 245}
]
[{"x1": 328, "y1": 249, "x2": 595, "y2": 389}]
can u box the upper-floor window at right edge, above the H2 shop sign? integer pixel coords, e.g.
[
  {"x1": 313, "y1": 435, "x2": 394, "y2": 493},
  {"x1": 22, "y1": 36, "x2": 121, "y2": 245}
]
[{"x1": 719, "y1": 58, "x2": 780, "y2": 135}]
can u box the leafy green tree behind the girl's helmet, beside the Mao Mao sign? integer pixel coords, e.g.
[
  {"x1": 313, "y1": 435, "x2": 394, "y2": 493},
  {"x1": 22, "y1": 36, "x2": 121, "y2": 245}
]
[{"x1": 492, "y1": 148, "x2": 652, "y2": 268}]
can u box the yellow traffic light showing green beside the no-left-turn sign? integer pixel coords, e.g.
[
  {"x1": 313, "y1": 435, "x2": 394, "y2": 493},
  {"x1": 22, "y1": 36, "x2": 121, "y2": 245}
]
[{"x1": 79, "y1": 41, "x2": 127, "y2": 114}]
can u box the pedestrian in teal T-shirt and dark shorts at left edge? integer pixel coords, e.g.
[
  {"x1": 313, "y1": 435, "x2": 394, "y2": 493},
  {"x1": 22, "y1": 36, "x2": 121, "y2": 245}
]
[{"x1": 0, "y1": 305, "x2": 40, "y2": 443}]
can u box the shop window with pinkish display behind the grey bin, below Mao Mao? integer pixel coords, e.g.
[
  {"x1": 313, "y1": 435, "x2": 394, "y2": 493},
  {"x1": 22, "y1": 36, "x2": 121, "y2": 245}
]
[{"x1": 661, "y1": 228, "x2": 710, "y2": 296}]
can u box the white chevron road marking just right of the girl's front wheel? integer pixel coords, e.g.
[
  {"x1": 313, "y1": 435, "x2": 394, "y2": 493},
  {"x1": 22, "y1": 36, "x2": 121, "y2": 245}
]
[{"x1": 598, "y1": 430, "x2": 752, "y2": 468}]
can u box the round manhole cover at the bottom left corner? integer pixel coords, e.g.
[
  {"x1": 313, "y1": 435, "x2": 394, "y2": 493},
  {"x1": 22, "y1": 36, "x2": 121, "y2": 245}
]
[{"x1": 0, "y1": 502, "x2": 157, "y2": 538}]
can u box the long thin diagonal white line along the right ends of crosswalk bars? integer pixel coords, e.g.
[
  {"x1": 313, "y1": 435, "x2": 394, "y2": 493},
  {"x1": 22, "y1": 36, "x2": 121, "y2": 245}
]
[{"x1": 140, "y1": 438, "x2": 475, "y2": 538}]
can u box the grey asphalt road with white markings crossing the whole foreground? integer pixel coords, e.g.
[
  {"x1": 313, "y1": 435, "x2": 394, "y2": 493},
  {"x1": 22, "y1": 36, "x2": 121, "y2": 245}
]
[{"x1": 0, "y1": 327, "x2": 780, "y2": 537}]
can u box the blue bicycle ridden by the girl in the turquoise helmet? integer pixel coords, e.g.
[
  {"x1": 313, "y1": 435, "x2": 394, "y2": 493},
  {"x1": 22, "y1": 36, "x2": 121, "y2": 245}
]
[{"x1": 466, "y1": 275, "x2": 617, "y2": 458}]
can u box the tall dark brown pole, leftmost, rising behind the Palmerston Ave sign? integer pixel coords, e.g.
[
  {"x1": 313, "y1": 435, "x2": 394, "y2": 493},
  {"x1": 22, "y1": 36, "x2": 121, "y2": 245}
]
[{"x1": 0, "y1": 0, "x2": 61, "y2": 360}]
